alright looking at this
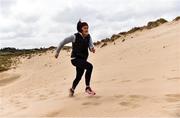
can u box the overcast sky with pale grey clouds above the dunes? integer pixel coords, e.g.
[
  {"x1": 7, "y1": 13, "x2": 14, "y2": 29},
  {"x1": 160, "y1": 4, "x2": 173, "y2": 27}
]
[{"x1": 0, "y1": 0, "x2": 180, "y2": 48}]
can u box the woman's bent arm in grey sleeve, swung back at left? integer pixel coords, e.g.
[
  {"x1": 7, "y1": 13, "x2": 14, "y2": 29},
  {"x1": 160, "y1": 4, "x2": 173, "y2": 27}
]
[{"x1": 55, "y1": 35, "x2": 75, "y2": 58}]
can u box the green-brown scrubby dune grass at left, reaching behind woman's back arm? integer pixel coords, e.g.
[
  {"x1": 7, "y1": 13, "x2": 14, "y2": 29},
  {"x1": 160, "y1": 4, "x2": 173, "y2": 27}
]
[{"x1": 0, "y1": 46, "x2": 71, "y2": 72}]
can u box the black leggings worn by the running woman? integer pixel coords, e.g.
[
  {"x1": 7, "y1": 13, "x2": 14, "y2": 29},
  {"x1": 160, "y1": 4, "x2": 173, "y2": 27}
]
[{"x1": 71, "y1": 58, "x2": 93, "y2": 89}]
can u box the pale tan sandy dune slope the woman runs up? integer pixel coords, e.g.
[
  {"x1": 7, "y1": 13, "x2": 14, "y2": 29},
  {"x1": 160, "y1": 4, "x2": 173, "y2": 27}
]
[{"x1": 0, "y1": 21, "x2": 180, "y2": 117}]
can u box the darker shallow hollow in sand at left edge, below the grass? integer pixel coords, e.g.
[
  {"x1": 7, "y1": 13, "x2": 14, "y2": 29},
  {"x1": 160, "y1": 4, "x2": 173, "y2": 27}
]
[{"x1": 0, "y1": 73, "x2": 20, "y2": 87}]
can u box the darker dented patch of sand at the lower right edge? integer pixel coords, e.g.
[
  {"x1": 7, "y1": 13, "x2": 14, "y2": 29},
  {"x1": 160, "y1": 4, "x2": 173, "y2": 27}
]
[{"x1": 165, "y1": 94, "x2": 180, "y2": 102}]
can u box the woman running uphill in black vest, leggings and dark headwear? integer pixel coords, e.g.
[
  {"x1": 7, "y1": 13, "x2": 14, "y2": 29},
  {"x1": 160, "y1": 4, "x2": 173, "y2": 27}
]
[{"x1": 55, "y1": 20, "x2": 96, "y2": 97}]
